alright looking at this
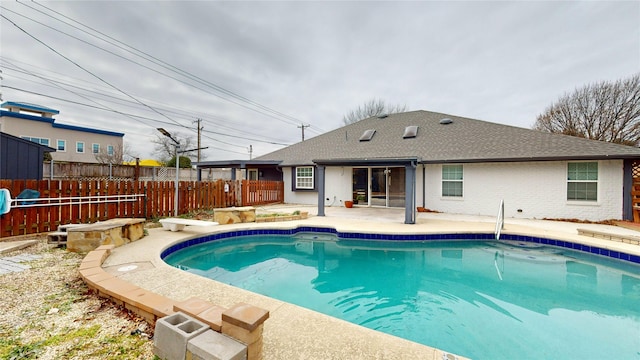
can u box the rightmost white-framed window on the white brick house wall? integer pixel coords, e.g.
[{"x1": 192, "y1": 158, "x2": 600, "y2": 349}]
[{"x1": 567, "y1": 162, "x2": 598, "y2": 201}]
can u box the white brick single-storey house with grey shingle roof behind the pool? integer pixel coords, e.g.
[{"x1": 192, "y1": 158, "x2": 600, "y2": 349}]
[{"x1": 196, "y1": 111, "x2": 640, "y2": 223}]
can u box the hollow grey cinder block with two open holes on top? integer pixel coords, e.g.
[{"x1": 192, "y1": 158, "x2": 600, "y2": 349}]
[{"x1": 153, "y1": 312, "x2": 209, "y2": 360}]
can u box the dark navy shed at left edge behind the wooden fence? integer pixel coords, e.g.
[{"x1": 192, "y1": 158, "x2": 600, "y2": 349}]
[{"x1": 0, "y1": 132, "x2": 56, "y2": 180}]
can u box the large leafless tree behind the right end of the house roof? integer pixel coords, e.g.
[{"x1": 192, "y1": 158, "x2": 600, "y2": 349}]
[{"x1": 533, "y1": 73, "x2": 640, "y2": 146}]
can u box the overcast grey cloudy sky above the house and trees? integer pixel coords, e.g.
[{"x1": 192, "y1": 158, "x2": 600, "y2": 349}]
[{"x1": 0, "y1": 0, "x2": 640, "y2": 161}]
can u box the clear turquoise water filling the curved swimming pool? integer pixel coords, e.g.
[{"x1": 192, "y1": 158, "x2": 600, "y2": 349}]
[{"x1": 163, "y1": 233, "x2": 640, "y2": 359}]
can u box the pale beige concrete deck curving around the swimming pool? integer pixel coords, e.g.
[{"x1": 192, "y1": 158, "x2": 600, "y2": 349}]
[{"x1": 102, "y1": 205, "x2": 640, "y2": 360}]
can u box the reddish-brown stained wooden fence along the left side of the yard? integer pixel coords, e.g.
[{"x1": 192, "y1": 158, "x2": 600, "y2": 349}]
[{"x1": 0, "y1": 180, "x2": 284, "y2": 238}]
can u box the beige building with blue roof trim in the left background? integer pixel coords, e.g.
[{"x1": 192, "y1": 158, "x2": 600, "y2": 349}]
[{"x1": 0, "y1": 101, "x2": 124, "y2": 163}]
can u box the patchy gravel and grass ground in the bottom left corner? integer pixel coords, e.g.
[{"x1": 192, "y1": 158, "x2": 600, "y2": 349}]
[{"x1": 0, "y1": 239, "x2": 154, "y2": 360}]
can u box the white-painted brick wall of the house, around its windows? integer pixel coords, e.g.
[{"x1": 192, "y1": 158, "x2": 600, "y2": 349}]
[{"x1": 283, "y1": 160, "x2": 624, "y2": 221}]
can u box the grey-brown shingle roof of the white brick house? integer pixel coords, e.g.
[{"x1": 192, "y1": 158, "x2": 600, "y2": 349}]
[{"x1": 256, "y1": 111, "x2": 640, "y2": 166}]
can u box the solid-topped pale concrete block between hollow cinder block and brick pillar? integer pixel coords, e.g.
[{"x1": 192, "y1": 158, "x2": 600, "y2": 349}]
[{"x1": 186, "y1": 330, "x2": 247, "y2": 360}]
